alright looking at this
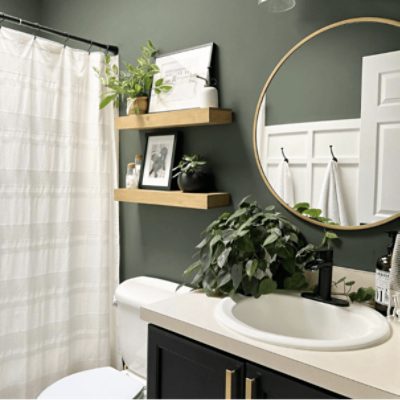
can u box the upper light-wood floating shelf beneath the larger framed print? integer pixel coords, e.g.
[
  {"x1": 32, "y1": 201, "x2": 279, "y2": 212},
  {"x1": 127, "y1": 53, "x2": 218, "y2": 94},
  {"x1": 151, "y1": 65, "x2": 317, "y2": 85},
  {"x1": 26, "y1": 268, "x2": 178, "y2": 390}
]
[{"x1": 115, "y1": 108, "x2": 232, "y2": 130}]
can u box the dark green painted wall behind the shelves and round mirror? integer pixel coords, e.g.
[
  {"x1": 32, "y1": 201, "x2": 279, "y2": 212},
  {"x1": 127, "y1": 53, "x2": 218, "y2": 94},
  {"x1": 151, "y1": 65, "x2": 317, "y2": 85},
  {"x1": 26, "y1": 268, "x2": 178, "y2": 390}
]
[{"x1": 0, "y1": 0, "x2": 400, "y2": 280}]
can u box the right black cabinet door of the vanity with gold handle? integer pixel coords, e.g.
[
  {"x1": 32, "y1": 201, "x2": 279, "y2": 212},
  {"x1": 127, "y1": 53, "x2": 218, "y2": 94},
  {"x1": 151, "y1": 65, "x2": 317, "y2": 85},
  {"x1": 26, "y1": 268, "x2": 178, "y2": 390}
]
[{"x1": 246, "y1": 362, "x2": 343, "y2": 399}]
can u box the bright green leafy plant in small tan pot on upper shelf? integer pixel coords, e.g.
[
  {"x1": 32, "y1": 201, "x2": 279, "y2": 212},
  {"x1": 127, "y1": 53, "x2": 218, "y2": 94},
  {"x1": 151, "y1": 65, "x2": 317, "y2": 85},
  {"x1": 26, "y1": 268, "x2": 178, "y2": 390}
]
[{"x1": 95, "y1": 40, "x2": 172, "y2": 115}]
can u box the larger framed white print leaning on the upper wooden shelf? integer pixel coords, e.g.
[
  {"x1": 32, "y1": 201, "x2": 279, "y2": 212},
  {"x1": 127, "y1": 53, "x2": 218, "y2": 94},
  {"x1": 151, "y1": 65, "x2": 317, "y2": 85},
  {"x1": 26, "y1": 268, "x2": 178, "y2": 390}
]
[{"x1": 149, "y1": 43, "x2": 215, "y2": 113}]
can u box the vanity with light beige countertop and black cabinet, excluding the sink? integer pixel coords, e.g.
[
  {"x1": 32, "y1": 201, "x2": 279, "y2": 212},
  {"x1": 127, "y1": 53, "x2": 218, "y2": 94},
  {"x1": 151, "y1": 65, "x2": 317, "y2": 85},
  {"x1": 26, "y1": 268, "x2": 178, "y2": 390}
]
[{"x1": 141, "y1": 292, "x2": 400, "y2": 398}]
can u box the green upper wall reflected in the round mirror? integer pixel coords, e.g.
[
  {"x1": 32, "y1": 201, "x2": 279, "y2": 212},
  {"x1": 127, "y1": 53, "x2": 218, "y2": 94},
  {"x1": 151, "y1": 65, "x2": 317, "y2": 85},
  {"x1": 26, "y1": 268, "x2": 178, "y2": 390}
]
[{"x1": 266, "y1": 23, "x2": 400, "y2": 125}]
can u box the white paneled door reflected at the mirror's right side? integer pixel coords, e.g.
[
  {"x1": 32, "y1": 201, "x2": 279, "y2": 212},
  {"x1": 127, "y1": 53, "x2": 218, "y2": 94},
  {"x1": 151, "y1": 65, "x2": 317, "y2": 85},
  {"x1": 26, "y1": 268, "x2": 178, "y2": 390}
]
[{"x1": 358, "y1": 51, "x2": 400, "y2": 223}]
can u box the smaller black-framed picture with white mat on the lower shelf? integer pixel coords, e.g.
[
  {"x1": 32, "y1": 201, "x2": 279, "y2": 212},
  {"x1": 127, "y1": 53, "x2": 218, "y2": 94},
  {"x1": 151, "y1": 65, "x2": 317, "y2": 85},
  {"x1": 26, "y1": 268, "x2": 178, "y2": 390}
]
[{"x1": 139, "y1": 132, "x2": 178, "y2": 190}]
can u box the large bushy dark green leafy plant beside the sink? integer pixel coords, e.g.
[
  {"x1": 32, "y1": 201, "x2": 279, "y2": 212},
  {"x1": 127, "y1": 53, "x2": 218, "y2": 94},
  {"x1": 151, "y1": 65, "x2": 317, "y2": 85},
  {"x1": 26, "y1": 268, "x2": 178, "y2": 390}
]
[{"x1": 184, "y1": 199, "x2": 334, "y2": 297}]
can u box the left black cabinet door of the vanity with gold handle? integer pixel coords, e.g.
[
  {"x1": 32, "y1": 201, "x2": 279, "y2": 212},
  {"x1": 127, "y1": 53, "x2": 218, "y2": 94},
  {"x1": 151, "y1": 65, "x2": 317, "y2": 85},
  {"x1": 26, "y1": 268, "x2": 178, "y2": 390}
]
[{"x1": 147, "y1": 325, "x2": 244, "y2": 399}]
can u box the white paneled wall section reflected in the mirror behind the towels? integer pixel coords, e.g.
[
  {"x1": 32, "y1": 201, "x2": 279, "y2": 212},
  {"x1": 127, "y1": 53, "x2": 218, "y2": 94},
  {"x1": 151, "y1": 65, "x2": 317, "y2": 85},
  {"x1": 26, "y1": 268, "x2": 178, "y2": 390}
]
[{"x1": 258, "y1": 119, "x2": 360, "y2": 225}]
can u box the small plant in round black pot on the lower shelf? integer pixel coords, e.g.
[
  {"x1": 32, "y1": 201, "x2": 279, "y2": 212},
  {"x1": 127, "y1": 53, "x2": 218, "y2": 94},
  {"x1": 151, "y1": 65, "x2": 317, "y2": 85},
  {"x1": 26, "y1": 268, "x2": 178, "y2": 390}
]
[{"x1": 173, "y1": 154, "x2": 213, "y2": 193}]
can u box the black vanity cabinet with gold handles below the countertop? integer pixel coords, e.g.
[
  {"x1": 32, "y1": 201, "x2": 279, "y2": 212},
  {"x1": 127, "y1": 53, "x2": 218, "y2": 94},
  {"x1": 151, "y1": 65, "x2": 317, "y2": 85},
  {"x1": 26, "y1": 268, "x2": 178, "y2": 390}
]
[{"x1": 147, "y1": 325, "x2": 342, "y2": 399}]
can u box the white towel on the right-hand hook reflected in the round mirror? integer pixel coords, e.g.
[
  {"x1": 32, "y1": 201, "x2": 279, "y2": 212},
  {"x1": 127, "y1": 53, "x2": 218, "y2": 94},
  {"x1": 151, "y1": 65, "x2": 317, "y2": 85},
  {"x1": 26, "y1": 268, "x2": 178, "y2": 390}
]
[{"x1": 318, "y1": 160, "x2": 350, "y2": 225}]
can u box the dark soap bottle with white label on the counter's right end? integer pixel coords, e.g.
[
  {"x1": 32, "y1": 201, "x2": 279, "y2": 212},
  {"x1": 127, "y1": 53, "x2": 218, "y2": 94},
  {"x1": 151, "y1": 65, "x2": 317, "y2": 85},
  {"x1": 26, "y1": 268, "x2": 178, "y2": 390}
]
[{"x1": 375, "y1": 231, "x2": 397, "y2": 315}]
